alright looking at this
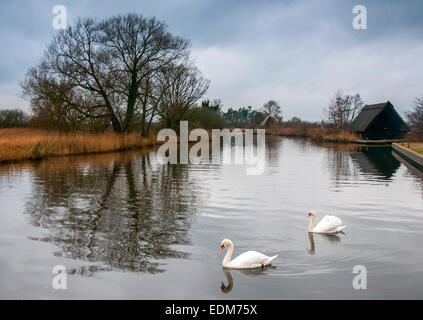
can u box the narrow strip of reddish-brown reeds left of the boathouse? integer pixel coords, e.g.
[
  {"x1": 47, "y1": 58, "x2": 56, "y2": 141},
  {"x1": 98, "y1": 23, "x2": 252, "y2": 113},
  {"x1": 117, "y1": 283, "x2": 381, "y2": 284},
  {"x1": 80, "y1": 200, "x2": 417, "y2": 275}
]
[{"x1": 266, "y1": 127, "x2": 360, "y2": 142}]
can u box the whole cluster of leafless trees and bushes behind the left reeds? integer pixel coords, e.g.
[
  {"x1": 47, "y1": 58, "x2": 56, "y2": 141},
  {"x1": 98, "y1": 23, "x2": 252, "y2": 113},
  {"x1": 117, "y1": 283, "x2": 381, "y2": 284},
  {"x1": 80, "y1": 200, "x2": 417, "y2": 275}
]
[{"x1": 21, "y1": 14, "x2": 210, "y2": 136}]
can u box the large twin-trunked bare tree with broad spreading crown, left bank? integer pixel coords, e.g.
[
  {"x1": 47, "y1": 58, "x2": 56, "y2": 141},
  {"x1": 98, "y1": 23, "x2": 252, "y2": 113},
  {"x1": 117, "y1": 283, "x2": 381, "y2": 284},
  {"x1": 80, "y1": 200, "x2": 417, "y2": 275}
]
[{"x1": 22, "y1": 14, "x2": 189, "y2": 133}]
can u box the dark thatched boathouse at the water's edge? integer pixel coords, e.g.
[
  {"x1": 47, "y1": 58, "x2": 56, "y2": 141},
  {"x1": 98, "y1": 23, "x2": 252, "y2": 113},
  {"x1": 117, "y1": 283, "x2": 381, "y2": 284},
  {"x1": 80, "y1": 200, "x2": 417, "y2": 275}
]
[{"x1": 348, "y1": 101, "x2": 409, "y2": 140}]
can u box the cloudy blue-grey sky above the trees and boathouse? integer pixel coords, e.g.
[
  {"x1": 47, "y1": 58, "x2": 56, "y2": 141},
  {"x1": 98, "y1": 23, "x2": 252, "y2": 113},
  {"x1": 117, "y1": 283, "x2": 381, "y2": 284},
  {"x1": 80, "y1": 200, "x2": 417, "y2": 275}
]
[{"x1": 0, "y1": 0, "x2": 423, "y2": 121}]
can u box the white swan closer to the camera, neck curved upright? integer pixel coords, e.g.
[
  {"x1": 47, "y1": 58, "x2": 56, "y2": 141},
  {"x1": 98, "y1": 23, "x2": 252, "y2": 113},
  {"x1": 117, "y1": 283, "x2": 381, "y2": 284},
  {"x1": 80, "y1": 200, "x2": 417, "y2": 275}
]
[{"x1": 220, "y1": 239, "x2": 277, "y2": 269}]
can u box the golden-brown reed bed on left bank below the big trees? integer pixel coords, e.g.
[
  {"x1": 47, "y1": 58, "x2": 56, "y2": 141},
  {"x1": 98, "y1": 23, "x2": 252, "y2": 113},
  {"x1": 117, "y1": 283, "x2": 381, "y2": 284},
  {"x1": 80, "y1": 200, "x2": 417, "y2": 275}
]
[{"x1": 0, "y1": 128, "x2": 156, "y2": 162}]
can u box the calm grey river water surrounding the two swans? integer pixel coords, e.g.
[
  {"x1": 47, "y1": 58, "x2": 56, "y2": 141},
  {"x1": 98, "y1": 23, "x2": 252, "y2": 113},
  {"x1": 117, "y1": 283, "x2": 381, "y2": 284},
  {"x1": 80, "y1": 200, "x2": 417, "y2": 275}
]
[{"x1": 0, "y1": 137, "x2": 423, "y2": 299}]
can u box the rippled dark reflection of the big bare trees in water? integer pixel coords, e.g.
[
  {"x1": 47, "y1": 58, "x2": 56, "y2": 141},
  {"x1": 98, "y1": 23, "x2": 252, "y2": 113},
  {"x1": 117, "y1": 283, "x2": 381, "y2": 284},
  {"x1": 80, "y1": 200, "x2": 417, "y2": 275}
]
[{"x1": 26, "y1": 153, "x2": 197, "y2": 273}]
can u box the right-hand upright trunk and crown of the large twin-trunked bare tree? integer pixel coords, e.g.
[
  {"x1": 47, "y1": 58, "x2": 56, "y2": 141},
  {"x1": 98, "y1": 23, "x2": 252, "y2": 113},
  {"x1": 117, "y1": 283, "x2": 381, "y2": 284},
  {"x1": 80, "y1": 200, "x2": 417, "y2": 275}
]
[{"x1": 100, "y1": 14, "x2": 189, "y2": 131}]
